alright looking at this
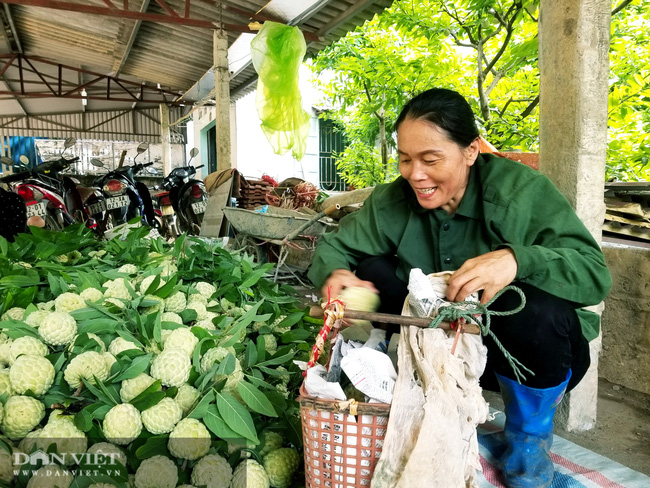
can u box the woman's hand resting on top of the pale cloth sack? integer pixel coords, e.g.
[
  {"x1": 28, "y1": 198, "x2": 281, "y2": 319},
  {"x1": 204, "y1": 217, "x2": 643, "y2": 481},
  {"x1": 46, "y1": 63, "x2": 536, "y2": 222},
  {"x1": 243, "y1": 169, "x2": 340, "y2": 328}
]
[{"x1": 447, "y1": 249, "x2": 517, "y2": 304}]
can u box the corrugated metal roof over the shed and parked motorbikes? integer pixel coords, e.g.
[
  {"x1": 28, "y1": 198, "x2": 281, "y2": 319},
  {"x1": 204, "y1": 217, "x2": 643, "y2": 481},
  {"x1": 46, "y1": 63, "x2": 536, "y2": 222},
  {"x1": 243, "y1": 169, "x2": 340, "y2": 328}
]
[{"x1": 0, "y1": 0, "x2": 392, "y2": 139}]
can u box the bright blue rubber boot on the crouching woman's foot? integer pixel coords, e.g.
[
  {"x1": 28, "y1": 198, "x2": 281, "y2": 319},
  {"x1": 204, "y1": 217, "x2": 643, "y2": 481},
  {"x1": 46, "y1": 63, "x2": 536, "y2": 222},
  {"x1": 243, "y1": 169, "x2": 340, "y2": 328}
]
[{"x1": 497, "y1": 370, "x2": 571, "y2": 488}]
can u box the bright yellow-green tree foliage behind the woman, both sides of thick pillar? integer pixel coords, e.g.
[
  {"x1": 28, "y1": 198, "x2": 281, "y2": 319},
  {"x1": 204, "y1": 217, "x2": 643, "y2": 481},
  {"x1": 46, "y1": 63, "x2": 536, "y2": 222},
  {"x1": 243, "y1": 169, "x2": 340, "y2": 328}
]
[{"x1": 312, "y1": 0, "x2": 650, "y2": 187}]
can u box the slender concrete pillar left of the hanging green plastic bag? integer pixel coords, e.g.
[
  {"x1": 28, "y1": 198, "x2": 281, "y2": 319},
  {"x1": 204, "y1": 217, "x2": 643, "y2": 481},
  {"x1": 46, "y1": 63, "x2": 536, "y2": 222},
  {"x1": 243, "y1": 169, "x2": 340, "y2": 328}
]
[{"x1": 213, "y1": 29, "x2": 232, "y2": 171}]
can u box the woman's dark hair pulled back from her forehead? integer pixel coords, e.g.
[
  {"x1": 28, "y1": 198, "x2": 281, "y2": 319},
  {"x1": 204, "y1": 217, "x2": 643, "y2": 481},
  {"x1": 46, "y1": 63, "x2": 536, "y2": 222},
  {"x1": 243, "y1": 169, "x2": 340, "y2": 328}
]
[{"x1": 394, "y1": 88, "x2": 479, "y2": 147}]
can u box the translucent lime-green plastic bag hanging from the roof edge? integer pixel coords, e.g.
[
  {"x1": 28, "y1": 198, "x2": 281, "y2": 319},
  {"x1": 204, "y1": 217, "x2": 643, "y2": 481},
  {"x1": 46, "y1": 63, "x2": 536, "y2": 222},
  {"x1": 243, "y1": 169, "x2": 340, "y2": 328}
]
[{"x1": 251, "y1": 21, "x2": 310, "y2": 160}]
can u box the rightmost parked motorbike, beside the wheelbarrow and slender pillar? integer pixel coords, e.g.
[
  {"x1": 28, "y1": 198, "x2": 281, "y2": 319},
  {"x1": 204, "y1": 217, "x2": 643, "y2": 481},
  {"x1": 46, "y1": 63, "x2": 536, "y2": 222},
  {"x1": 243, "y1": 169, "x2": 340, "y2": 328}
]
[{"x1": 155, "y1": 148, "x2": 208, "y2": 237}]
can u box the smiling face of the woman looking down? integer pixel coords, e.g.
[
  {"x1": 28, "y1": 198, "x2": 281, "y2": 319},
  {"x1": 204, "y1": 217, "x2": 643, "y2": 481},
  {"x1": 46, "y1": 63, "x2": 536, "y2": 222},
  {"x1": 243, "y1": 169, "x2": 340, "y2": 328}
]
[{"x1": 397, "y1": 118, "x2": 479, "y2": 214}]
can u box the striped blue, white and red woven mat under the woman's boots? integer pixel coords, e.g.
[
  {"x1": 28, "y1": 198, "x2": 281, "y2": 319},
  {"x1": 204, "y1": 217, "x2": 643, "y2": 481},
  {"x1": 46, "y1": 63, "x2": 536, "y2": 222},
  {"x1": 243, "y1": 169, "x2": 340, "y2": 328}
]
[{"x1": 478, "y1": 412, "x2": 650, "y2": 488}]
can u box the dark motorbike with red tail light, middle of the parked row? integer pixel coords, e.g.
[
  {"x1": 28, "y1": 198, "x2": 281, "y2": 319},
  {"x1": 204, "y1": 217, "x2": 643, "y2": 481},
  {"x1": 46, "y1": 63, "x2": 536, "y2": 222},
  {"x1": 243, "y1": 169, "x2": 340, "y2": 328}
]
[{"x1": 94, "y1": 143, "x2": 156, "y2": 232}]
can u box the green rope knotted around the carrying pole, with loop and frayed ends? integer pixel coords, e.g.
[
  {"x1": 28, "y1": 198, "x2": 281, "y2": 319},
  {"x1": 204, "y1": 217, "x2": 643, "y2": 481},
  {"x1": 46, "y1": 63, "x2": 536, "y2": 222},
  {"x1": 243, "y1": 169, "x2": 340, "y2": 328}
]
[{"x1": 429, "y1": 285, "x2": 535, "y2": 384}]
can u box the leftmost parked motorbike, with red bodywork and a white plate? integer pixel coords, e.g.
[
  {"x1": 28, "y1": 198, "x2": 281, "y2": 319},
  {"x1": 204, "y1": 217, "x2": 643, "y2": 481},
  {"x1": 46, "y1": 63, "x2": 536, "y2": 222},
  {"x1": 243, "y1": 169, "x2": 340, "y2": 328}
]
[{"x1": 0, "y1": 138, "x2": 94, "y2": 230}]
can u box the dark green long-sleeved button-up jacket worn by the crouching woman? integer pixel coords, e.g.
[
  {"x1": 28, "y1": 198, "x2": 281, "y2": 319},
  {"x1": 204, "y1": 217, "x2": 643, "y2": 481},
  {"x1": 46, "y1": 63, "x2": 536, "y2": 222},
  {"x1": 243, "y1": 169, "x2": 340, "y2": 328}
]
[{"x1": 308, "y1": 154, "x2": 611, "y2": 340}]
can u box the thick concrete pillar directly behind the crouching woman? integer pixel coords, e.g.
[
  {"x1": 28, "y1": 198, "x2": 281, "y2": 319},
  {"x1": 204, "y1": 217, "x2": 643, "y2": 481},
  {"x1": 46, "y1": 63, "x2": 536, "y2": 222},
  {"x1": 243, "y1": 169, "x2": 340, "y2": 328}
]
[{"x1": 539, "y1": 0, "x2": 611, "y2": 430}]
